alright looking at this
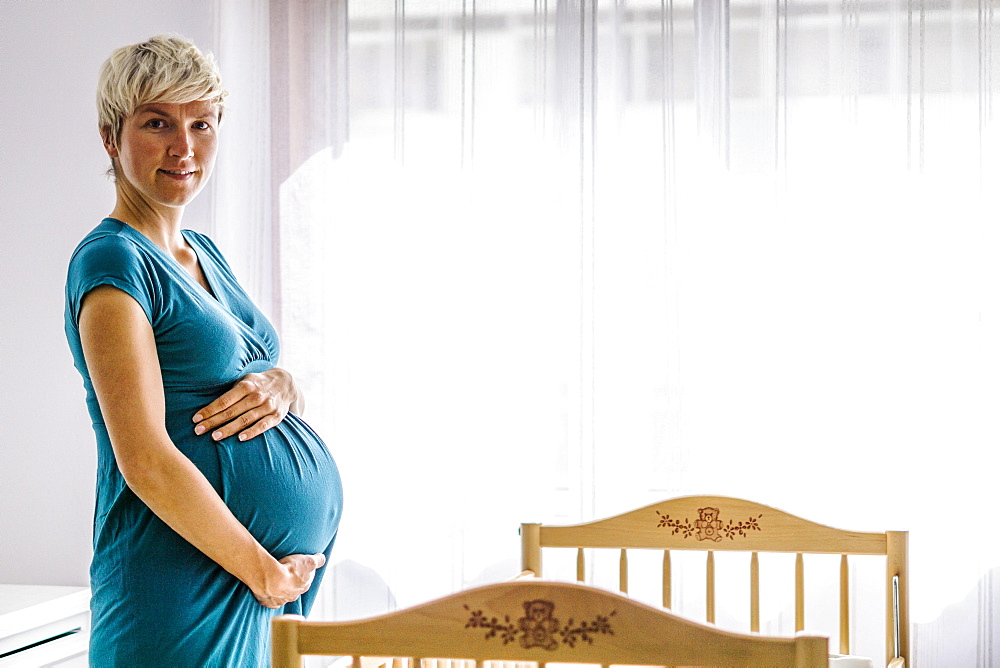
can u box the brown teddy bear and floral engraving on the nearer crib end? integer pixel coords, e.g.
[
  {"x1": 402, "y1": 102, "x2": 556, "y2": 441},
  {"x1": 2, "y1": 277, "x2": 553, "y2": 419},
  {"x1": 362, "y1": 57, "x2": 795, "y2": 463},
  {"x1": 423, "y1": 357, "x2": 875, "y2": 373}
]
[{"x1": 465, "y1": 600, "x2": 615, "y2": 651}]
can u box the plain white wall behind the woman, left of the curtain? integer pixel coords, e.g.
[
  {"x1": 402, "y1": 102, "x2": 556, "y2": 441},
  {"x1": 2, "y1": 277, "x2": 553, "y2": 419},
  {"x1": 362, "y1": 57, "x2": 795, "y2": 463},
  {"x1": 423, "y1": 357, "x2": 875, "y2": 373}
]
[{"x1": 0, "y1": 0, "x2": 218, "y2": 585}]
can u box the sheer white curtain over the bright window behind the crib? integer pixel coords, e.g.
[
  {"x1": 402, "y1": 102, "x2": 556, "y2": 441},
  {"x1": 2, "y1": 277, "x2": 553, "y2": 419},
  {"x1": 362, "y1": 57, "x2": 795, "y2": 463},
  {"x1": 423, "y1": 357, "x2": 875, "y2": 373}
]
[{"x1": 218, "y1": 0, "x2": 1000, "y2": 666}]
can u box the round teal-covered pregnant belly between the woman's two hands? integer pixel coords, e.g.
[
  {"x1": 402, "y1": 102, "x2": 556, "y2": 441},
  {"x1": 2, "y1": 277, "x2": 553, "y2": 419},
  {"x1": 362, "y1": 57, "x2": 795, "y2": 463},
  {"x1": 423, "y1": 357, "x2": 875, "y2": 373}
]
[{"x1": 170, "y1": 413, "x2": 343, "y2": 559}]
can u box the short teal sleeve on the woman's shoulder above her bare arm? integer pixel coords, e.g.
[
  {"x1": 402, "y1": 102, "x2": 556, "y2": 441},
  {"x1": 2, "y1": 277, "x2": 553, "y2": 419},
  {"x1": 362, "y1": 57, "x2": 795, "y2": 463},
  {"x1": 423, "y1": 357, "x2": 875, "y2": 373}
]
[{"x1": 66, "y1": 235, "x2": 157, "y2": 326}]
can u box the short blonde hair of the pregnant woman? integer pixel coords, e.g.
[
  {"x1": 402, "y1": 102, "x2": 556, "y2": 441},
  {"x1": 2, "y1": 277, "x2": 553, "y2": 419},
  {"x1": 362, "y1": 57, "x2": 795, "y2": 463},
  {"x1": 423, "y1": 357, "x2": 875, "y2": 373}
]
[{"x1": 97, "y1": 34, "x2": 228, "y2": 146}]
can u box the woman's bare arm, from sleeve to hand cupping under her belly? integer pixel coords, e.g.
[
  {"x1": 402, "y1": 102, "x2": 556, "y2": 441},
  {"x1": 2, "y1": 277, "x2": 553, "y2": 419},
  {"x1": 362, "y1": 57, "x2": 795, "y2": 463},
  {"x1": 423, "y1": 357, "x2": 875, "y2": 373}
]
[{"x1": 80, "y1": 286, "x2": 324, "y2": 608}]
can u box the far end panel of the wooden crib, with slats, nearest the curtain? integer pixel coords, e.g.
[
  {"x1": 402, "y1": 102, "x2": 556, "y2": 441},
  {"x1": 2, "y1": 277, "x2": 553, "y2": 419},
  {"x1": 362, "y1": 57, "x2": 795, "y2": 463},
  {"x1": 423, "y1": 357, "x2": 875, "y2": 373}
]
[{"x1": 521, "y1": 496, "x2": 910, "y2": 668}]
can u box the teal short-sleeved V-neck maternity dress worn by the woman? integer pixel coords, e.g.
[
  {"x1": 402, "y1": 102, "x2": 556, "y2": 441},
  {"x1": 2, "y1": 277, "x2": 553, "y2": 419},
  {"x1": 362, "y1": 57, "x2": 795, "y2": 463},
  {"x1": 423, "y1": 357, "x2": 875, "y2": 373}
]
[{"x1": 65, "y1": 218, "x2": 343, "y2": 668}]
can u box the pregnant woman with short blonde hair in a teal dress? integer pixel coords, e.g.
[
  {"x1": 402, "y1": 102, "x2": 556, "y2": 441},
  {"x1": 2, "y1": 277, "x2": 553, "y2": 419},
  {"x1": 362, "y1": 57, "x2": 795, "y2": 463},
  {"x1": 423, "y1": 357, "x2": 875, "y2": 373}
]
[{"x1": 66, "y1": 35, "x2": 342, "y2": 667}]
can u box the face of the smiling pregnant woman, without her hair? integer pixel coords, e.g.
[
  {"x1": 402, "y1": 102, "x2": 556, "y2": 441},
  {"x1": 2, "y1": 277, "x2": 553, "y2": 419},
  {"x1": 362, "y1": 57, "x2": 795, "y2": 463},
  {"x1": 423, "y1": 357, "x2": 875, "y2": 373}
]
[{"x1": 105, "y1": 102, "x2": 219, "y2": 208}]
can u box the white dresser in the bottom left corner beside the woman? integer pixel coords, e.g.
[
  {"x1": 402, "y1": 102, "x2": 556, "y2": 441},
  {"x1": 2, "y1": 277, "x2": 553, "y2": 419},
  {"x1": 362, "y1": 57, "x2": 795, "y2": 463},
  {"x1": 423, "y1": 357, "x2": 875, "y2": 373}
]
[{"x1": 0, "y1": 584, "x2": 90, "y2": 668}]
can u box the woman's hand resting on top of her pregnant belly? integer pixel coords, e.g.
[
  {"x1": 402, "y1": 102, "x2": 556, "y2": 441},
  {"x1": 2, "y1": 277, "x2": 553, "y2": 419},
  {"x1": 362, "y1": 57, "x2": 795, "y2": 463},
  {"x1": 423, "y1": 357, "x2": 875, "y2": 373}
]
[{"x1": 193, "y1": 367, "x2": 299, "y2": 441}]
